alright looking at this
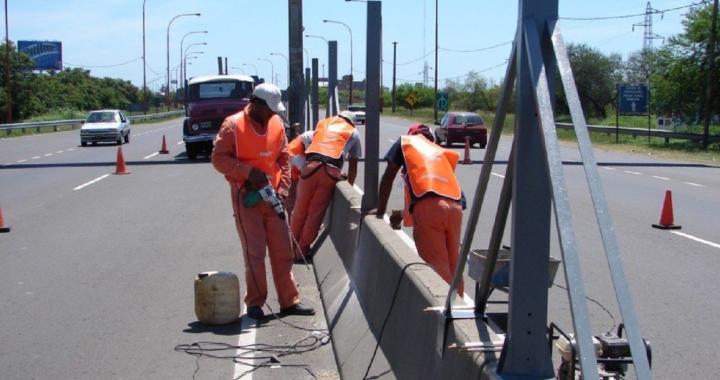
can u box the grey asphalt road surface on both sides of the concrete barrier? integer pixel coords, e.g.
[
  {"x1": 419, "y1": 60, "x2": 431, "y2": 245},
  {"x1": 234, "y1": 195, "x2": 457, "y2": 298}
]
[{"x1": 0, "y1": 117, "x2": 720, "y2": 380}]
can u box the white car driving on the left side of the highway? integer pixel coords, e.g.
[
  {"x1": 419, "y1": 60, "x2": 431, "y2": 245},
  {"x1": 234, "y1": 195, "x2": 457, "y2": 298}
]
[{"x1": 80, "y1": 110, "x2": 130, "y2": 146}]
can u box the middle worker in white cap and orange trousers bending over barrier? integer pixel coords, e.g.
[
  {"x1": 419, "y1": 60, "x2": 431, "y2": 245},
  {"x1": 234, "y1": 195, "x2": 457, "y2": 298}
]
[{"x1": 290, "y1": 111, "x2": 362, "y2": 260}]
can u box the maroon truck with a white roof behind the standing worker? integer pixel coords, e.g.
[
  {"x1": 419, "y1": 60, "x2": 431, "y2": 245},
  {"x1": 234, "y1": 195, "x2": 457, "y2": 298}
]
[{"x1": 183, "y1": 75, "x2": 255, "y2": 160}]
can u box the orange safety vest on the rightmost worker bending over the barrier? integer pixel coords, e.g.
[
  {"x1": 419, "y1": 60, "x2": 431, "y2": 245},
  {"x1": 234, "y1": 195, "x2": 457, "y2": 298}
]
[{"x1": 400, "y1": 136, "x2": 462, "y2": 227}]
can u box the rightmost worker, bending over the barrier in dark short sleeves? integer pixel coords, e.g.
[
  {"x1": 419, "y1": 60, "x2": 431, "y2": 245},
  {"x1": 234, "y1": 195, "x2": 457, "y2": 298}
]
[{"x1": 368, "y1": 124, "x2": 465, "y2": 296}]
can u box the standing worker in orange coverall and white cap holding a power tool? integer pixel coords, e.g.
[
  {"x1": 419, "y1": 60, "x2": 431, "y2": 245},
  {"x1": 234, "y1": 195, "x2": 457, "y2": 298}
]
[{"x1": 212, "y1": 83, "x2": 315, "y2": 319}]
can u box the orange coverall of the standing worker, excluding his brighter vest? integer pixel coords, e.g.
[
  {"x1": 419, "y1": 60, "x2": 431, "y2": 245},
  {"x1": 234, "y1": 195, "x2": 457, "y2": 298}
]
[{"x1": 211, "y1": 111, "x2": 300, "y2": 308}]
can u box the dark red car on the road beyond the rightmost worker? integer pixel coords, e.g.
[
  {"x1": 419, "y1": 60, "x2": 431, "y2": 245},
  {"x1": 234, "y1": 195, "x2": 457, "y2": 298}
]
[{"x1": 435, "y1": 112, "x2": 487, "y2": 149}]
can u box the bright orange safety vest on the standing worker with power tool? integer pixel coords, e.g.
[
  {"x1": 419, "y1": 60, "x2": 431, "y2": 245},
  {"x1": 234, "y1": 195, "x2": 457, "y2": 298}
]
[{"x1": 231, "y1": 108, "x2": 285, "y2": 190}]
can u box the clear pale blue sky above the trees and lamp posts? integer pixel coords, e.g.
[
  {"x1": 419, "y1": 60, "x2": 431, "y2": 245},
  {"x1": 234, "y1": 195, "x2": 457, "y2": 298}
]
[{"x1": 2, "y1": 0, "x2": 699, "y2": 88}]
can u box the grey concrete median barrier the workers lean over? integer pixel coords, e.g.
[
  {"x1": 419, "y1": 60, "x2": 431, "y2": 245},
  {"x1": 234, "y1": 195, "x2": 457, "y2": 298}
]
[{"x1": 313, "y1": 182, "x2": 494, "y2": 379}]
